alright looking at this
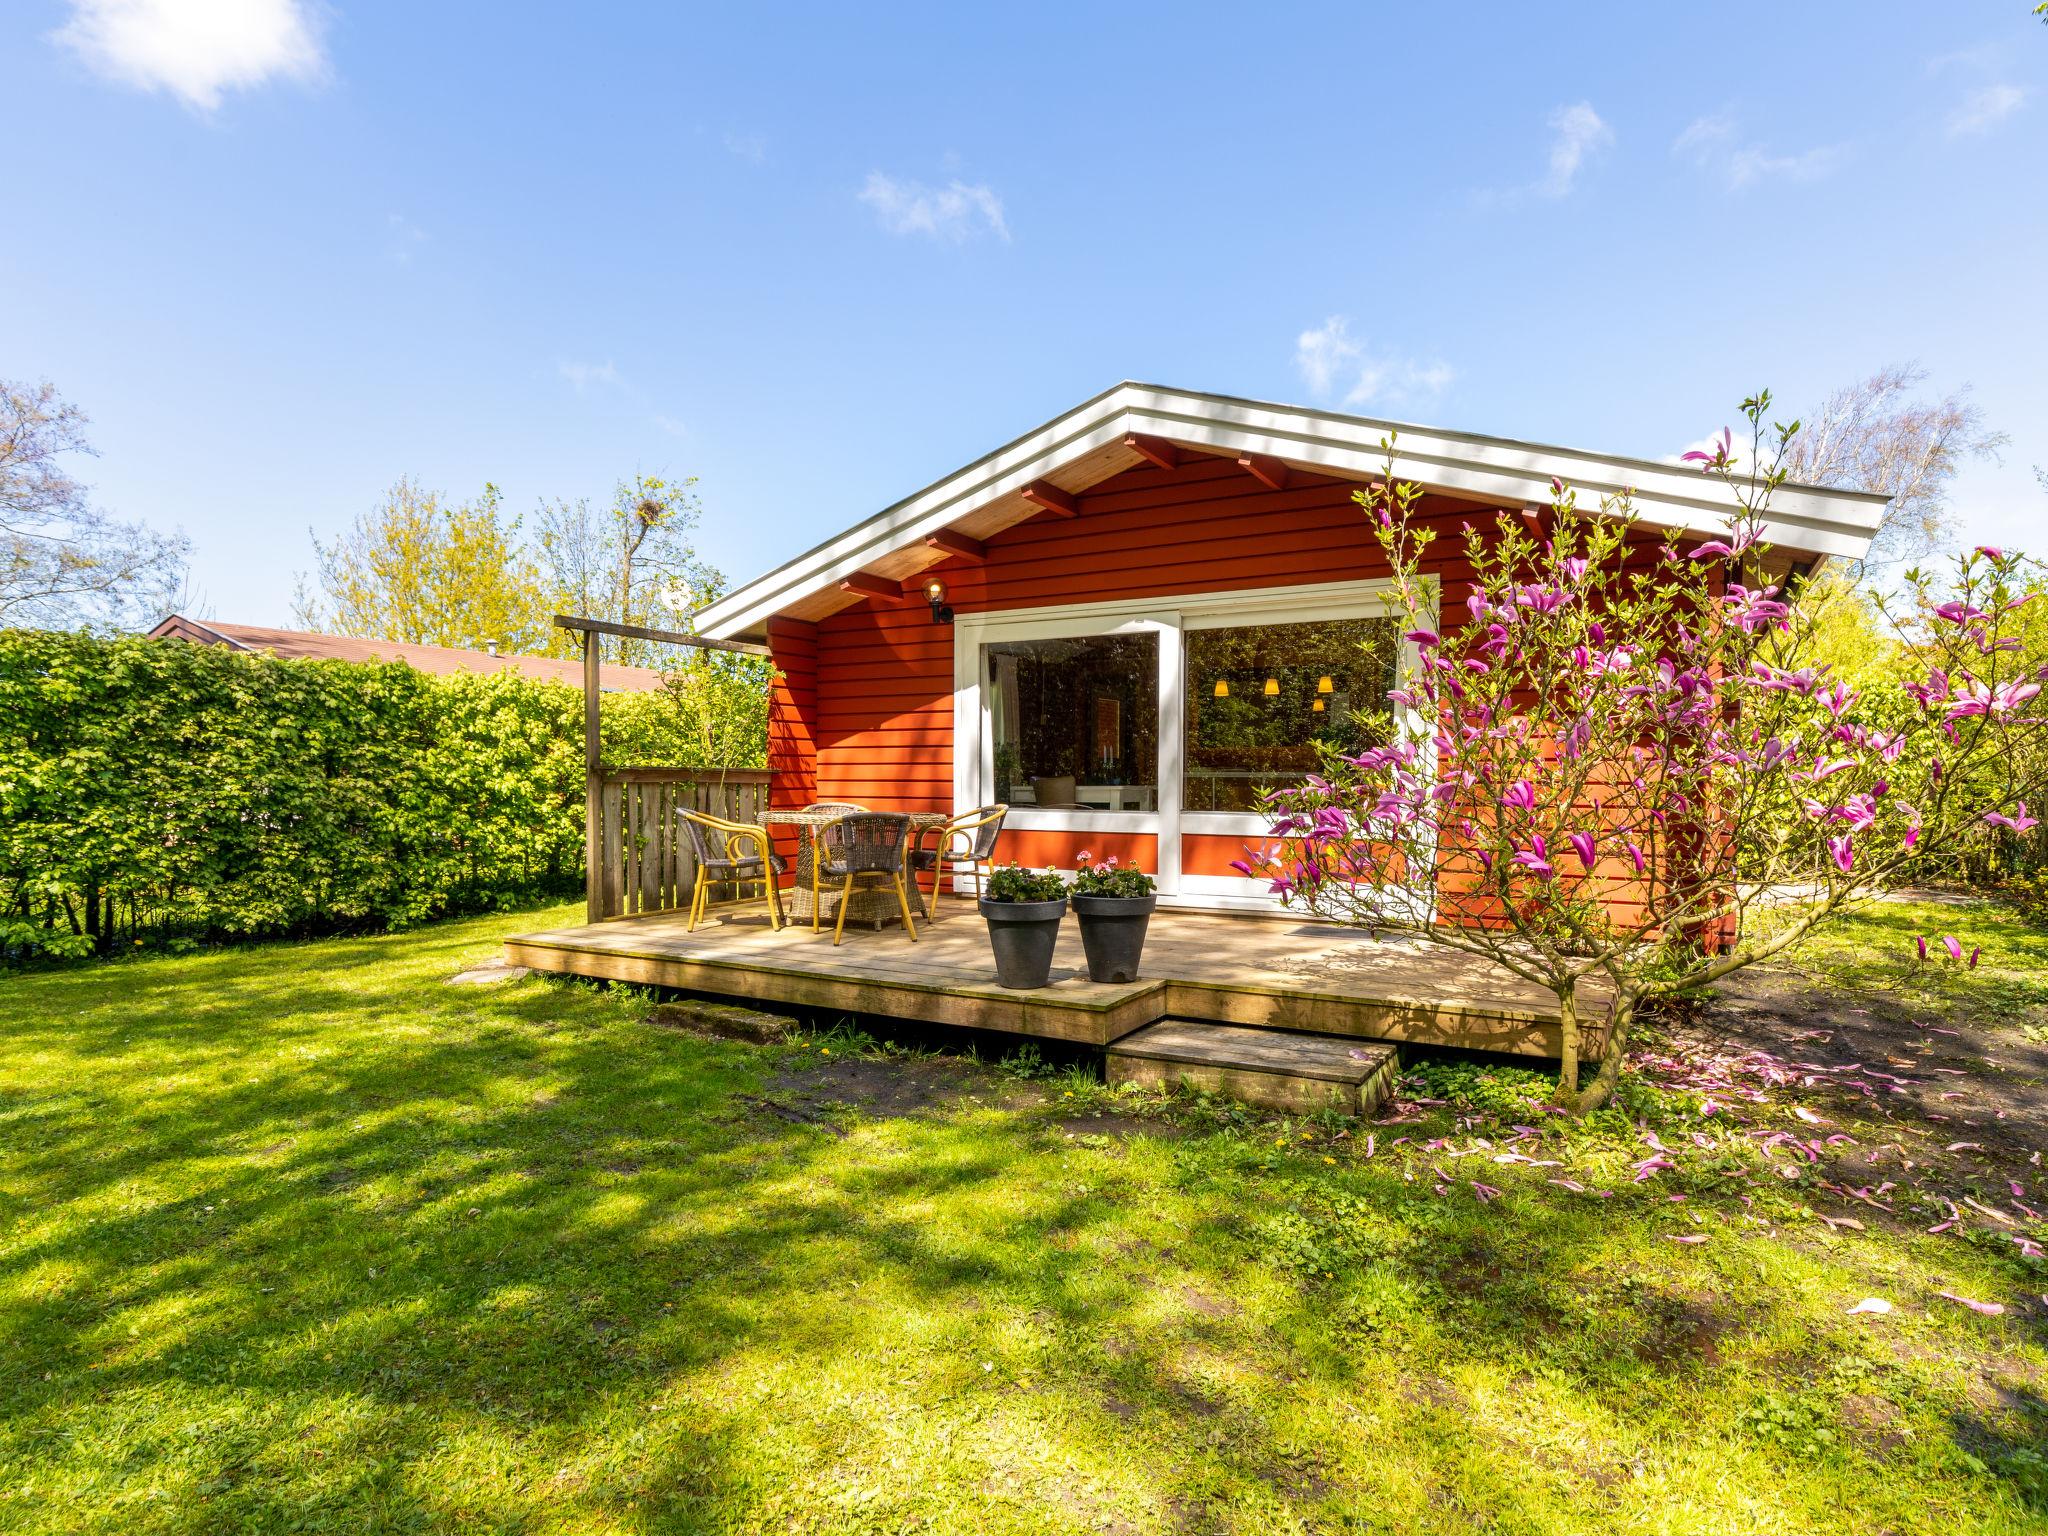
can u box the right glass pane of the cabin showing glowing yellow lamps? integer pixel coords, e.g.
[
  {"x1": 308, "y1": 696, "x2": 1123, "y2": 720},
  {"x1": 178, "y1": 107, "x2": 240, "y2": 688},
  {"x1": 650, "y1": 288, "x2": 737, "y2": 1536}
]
[{"x1": 1182, "y1": 618, "x2": 1399, "y2": 811}]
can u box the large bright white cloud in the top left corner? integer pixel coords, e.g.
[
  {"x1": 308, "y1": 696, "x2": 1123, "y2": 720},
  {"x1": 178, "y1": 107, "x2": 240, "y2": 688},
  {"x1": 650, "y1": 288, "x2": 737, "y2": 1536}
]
[{"x1": 49, "y1": 0, "x2": 328, "y2": 113}]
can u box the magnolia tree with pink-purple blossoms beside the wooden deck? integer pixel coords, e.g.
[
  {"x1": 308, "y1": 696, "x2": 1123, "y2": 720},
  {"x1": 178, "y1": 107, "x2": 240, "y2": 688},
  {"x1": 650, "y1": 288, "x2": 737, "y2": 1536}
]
[{"x1": 1239, "y1": 393, "x2": 2048, "y2": 1110}]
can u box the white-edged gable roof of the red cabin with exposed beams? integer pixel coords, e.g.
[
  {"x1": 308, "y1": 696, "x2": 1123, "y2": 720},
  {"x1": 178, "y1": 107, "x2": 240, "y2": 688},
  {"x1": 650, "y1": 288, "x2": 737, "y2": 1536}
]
[{"x1": 696, "y1": 383, "x2": 1888, "y2": 639}]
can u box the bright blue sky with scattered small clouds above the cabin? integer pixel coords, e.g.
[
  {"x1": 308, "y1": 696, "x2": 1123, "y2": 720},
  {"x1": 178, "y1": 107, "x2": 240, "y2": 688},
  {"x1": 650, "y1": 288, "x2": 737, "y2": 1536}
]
[{"x1": 0, "y1": 0, "x2": 2048, "y2": 623}]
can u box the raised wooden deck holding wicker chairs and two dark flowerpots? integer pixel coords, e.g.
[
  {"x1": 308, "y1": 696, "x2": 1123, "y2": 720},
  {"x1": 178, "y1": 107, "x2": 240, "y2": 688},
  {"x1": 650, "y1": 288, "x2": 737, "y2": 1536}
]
[{"x1": 506, "y1": 899, "x2": 1604, "y2": 1057}]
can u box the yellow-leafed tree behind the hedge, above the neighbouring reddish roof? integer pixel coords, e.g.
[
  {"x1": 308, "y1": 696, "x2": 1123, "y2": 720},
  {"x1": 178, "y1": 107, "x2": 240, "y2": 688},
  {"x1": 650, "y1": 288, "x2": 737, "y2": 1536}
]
[{"x1": 293, "y1": 479, "x2": 553, "y2": 651}]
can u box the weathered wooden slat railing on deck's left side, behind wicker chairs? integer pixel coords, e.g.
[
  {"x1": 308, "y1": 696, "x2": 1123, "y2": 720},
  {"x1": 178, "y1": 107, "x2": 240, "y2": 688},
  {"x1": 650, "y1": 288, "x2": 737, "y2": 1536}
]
[{"x1": 584, "y1": 768, "x2": 768, "y2": 922}]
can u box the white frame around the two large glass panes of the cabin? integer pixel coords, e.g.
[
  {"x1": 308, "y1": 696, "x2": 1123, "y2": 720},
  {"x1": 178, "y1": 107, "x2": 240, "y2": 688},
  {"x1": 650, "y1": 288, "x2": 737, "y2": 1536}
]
[{"x1": 952, "y1": 580, "x2": 1438, "y2": 911}]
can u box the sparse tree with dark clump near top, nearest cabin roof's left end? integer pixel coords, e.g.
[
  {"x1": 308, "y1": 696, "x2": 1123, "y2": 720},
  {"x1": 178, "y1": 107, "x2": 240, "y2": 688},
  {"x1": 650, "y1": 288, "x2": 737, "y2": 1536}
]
[{"x1": 539, "y1": 475, "x2": 725, "y2": 666}]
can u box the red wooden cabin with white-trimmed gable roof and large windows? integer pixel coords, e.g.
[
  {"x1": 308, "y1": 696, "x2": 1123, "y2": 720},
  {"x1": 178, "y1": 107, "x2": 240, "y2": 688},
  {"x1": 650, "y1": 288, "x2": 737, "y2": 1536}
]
[{"x1": 700, "y1": 383, "x2": 1884, "y2": 909}]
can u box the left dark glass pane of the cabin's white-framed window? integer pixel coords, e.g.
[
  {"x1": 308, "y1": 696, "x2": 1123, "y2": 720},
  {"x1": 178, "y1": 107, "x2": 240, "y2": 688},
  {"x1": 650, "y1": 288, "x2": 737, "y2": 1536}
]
[{"x1": 981, "y1": 633, "x2": 1159, "y2": 811}]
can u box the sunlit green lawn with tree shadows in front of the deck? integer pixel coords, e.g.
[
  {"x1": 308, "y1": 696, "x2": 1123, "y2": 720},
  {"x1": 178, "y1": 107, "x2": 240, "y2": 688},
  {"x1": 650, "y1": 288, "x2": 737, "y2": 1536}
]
[{"x1": 0, "y1": 909, "x2": 2048, "y2": 1536}]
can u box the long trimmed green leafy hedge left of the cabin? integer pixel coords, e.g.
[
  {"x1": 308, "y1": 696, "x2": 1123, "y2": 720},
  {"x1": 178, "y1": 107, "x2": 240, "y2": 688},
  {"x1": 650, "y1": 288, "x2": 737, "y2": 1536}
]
[{"x1": 0, "y1": 631, "x2": 766, "y2": 963}]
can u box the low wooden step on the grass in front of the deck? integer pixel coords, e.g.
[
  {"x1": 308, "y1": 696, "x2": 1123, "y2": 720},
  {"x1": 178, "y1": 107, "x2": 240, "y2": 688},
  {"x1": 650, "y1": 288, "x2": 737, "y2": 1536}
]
[{"x1": 1104, "y1": 1018, "x2": 1401, "y2": 1114}]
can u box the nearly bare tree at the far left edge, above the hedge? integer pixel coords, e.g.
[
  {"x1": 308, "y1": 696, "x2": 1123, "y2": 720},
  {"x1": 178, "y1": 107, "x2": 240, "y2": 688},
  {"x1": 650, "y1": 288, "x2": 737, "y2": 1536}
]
[{"x1": 0, "y1": 379, "x2": 188, "y2": 629}]
